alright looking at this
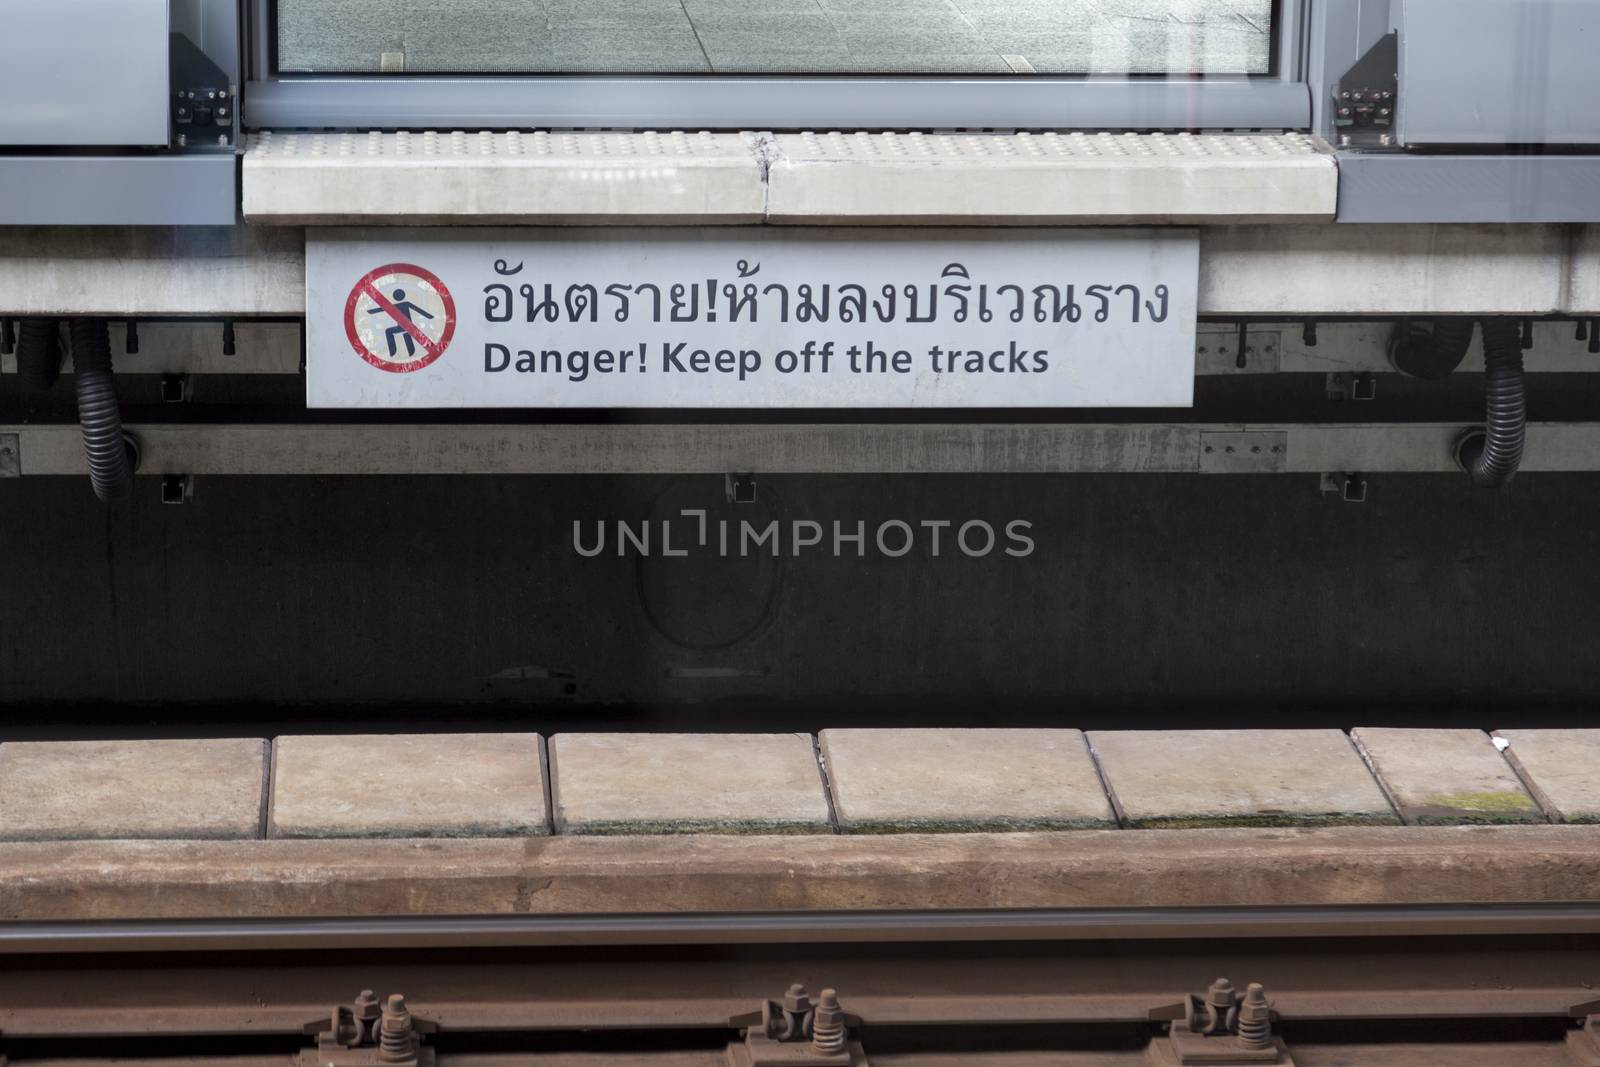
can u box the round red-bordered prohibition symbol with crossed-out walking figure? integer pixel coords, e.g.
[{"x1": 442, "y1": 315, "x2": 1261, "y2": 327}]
[{"x1": 344, "y1": 262, "x2": 456, "y2": 374}]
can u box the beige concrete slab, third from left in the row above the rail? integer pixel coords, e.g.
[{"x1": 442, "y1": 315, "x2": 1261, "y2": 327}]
[{"x1": 550, "y1": 734, "x2": 832, "y2": 833}]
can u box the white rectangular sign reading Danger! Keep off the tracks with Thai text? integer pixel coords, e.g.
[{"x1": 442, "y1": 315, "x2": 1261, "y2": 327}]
[{"x1": 306, "y1": 227, "x2": 1198, "y2": 410}]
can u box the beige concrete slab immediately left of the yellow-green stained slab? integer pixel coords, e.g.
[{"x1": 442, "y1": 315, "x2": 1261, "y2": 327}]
[{"x1": 1088, "y1": 729, "x2": 1398, "y2": 827}]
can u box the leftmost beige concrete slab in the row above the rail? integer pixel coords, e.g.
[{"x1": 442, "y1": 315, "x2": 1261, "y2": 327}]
[{"x1": 0, "y1": 737, "x2": 267, "y2": 841}]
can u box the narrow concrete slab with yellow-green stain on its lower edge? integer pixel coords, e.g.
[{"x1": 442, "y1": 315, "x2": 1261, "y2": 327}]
[{"x1": 1350, "y1": 726, "x2": 1546, "y2": 825}]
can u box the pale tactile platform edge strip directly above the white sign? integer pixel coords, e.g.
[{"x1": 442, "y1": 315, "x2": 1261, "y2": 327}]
[{"x1": 243, "y1": 130, "x2": 1338, "y2": 226}]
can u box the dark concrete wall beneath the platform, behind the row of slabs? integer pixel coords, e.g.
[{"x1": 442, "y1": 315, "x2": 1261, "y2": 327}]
[{"x1": 0, "y1": 475, "x2": 1600, "y2": 728}]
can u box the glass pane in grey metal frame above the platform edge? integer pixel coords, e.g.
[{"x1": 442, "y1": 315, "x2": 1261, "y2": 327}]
[{"x1": 277, "y1": 0, "x2": 1274, "y2": 75}]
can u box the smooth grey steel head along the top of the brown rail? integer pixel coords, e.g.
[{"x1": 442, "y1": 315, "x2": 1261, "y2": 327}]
[{"x1": 9, "y1": 904, "x2": 1600, "y2": 955}]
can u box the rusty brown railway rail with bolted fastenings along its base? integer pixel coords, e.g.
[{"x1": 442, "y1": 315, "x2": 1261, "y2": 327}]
[{"x1": 0, "y1": 904, "x2": 1600, "y2": 1067}]
